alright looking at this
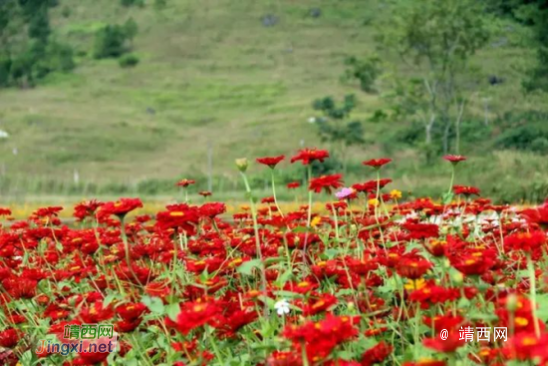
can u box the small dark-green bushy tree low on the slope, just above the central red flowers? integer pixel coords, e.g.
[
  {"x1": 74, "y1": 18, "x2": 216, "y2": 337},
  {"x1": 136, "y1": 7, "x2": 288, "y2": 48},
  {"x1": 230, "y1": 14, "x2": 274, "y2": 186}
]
[{"x1": 312, "y1": 95, "x2": 365, "y2": 170}]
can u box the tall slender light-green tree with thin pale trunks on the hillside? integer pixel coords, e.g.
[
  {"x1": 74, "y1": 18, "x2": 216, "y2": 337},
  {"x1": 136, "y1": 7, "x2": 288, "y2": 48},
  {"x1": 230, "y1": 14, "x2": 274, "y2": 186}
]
[{"x1": 378, "y1": 0, "x2": 490, "y2": 153}]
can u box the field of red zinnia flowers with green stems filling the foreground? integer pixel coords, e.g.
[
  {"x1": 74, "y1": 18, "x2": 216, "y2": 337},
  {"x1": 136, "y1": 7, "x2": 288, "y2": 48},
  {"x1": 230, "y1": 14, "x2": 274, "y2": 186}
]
[{"x1": 0, "y1": 149, "x2": 548, "y2": 366}]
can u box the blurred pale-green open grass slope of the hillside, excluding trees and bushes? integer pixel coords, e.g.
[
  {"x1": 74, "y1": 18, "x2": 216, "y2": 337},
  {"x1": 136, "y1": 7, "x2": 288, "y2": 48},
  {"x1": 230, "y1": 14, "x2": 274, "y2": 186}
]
[{"x1": 0, "y1": 0, "x2": 545, "y2": 202}]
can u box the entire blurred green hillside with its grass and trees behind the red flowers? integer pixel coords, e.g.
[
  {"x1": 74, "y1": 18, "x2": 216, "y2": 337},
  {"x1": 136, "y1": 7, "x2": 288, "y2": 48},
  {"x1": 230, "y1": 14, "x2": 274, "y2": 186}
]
[{"x1": 0, "y1": 0, "x2": 548, "y2": 203}]
